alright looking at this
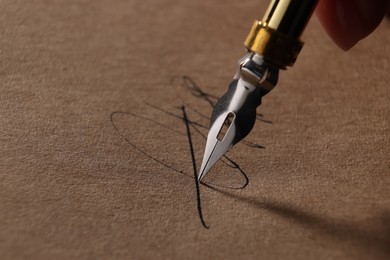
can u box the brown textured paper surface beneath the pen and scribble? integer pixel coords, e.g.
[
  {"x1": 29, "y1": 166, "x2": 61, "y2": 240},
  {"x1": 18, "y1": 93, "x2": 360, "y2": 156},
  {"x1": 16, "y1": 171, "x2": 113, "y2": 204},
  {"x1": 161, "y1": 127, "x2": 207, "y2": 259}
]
[{"x1": 0, "y1": 0, "x2": 390, "y2": 259}]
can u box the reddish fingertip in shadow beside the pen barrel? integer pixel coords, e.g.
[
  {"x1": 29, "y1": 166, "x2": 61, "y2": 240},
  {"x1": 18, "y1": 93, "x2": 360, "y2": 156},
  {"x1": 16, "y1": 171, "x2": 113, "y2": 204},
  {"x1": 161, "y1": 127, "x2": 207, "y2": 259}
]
[{"x1": 316, "y1": 0, "x2": 389, "y2": 50}]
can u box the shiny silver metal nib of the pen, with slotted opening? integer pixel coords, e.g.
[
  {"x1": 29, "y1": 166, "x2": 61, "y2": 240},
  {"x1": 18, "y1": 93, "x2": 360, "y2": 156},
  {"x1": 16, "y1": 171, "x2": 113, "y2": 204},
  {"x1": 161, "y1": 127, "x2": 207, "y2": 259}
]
[{"x1": 198, "y1": 53, "x2": 279, "y2": 181}]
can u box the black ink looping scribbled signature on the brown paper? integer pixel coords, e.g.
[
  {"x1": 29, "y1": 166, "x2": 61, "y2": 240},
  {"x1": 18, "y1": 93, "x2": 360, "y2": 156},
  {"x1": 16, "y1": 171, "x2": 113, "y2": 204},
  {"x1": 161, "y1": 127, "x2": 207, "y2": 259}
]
[{"x1": 110, "y1": 76, "x2": 272, "y2": 229}]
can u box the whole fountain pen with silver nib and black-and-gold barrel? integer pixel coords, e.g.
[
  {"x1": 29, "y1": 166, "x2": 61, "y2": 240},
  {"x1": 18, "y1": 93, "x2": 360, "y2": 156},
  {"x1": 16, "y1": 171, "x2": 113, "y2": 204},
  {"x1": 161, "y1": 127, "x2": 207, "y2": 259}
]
[{"x1": 198, "y1": 0, "x2": 318, "y2": 181}]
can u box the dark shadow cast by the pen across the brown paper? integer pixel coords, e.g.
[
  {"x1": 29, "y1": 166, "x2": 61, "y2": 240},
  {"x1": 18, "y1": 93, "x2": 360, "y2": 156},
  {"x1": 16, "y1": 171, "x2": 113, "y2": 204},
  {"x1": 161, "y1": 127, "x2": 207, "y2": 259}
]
[{"x1": 204, "y1": 184, "x2": 390, "y2": 258}]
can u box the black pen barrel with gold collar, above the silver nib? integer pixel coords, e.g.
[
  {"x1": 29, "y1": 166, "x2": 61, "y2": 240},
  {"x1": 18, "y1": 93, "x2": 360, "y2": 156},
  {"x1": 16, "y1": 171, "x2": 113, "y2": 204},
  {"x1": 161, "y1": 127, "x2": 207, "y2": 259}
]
[{"x1": 245, "y1": 0, "x2": 318, "y2": 69}]
